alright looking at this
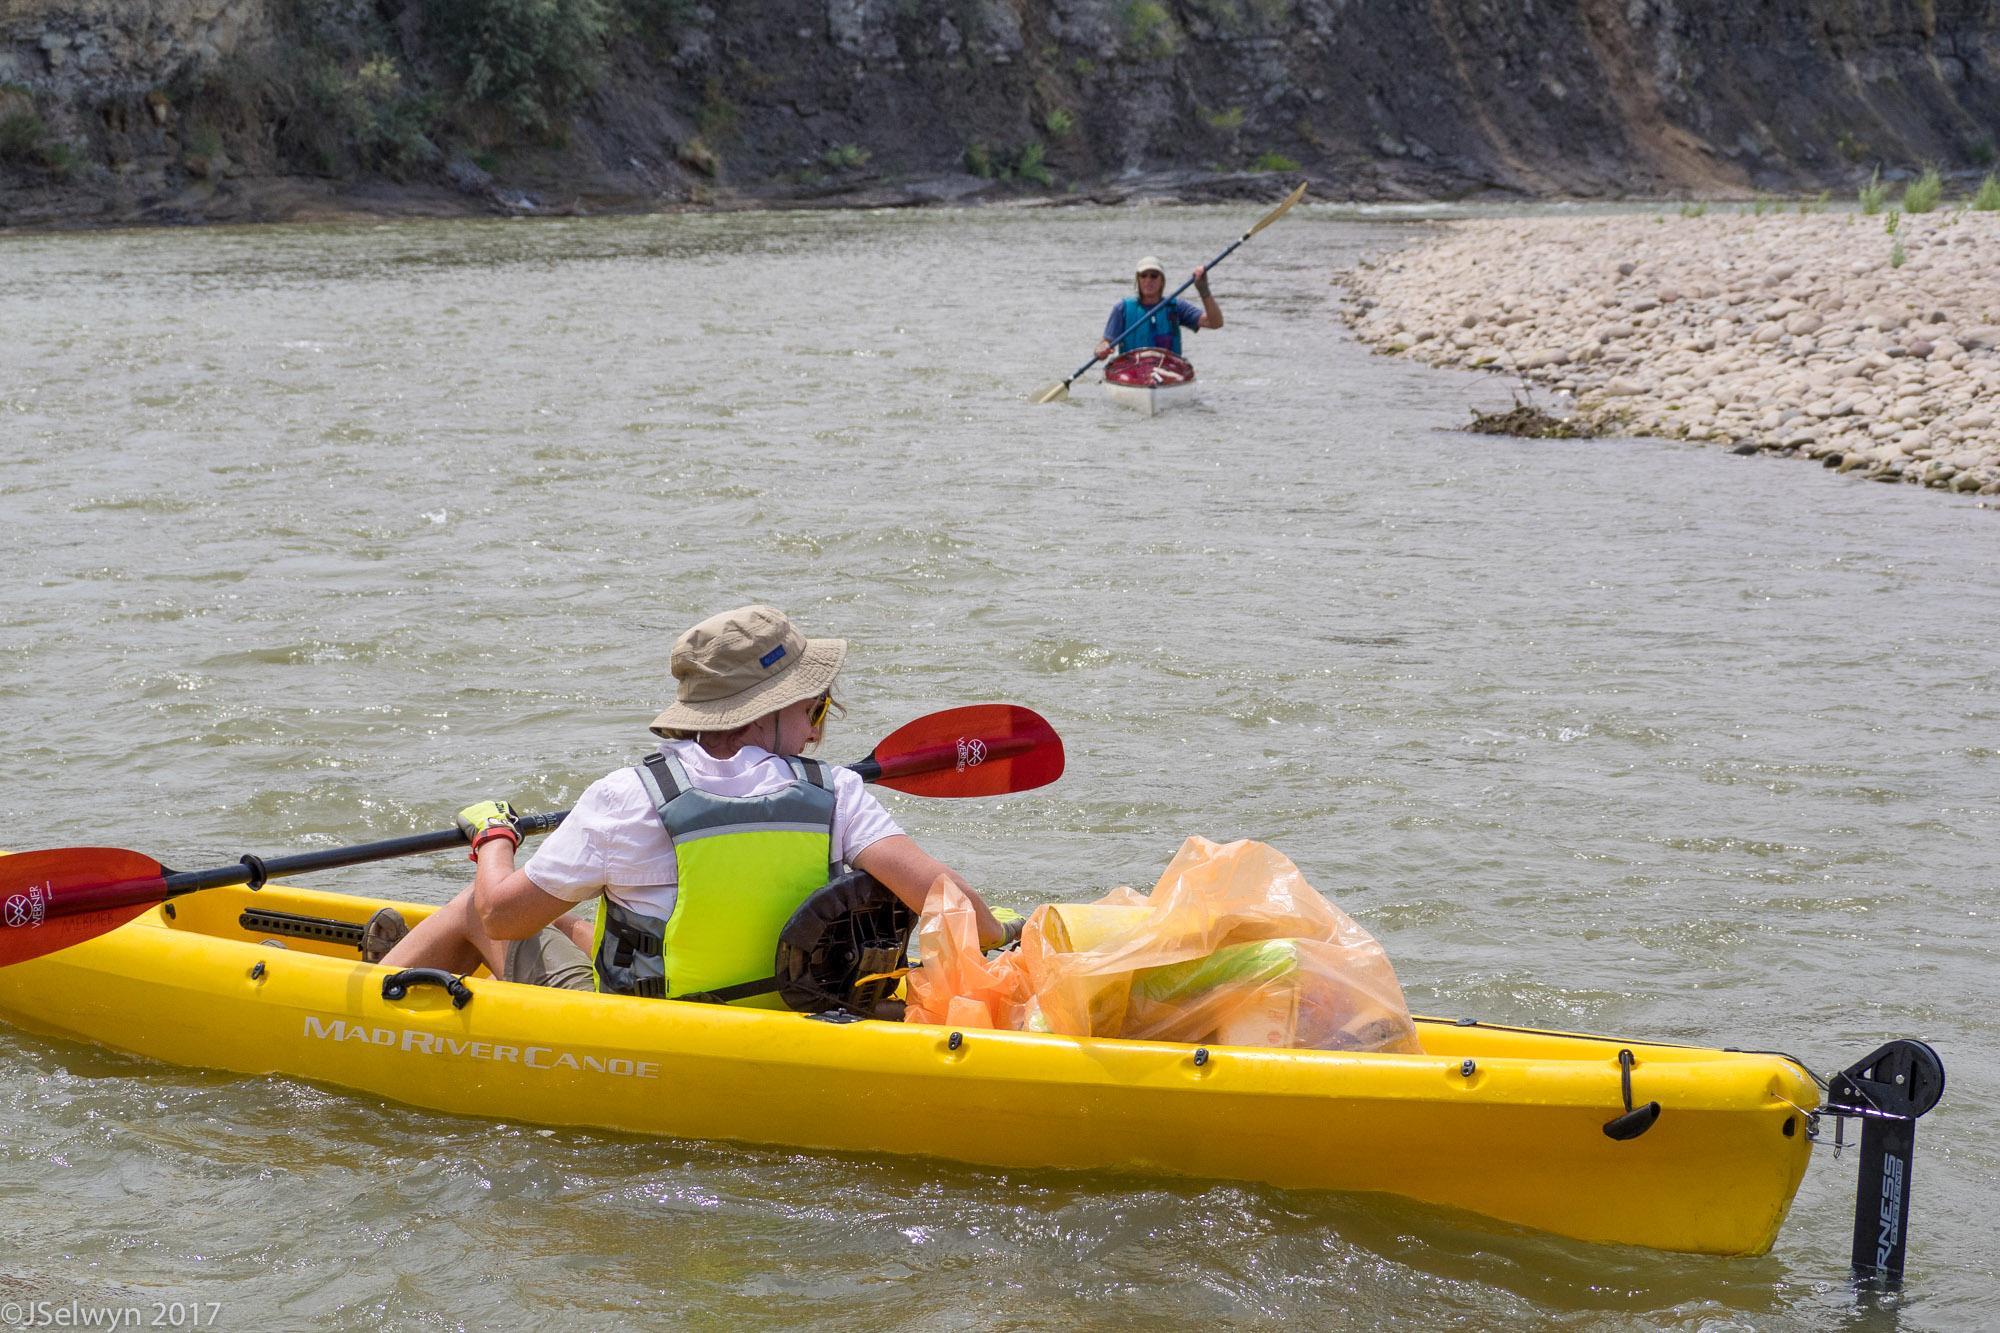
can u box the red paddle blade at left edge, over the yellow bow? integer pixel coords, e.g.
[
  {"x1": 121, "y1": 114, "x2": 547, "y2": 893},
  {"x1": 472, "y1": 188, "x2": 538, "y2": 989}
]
[{"x1": 0, "y1": 847, "x2": 166, "y2": 967}]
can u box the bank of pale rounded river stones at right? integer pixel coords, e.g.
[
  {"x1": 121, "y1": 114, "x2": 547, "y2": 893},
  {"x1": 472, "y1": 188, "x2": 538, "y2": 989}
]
[{"x1": 1342, "y1": 206, "x2": 2000, "y2": 496}]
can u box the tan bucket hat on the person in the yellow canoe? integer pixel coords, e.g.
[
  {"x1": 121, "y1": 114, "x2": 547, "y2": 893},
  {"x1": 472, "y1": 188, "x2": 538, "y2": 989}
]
[{"x1": 652, "y1": 606, "x2": 848, "y2": 737}]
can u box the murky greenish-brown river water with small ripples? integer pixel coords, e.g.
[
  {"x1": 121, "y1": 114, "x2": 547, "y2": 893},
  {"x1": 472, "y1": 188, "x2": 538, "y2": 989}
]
[{"x1": 0, "y1": 206, "x2": 2000, "y2": 1329}]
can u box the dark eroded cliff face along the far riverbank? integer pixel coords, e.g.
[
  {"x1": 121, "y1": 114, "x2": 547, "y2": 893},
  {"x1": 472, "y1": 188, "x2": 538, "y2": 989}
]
[{"x1": 0, "y1": 0, "x2": 2000, "y2": 222}]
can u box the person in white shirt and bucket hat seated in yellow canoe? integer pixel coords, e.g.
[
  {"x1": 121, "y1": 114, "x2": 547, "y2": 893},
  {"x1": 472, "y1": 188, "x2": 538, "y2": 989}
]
[{"x1": 364, "y1": 606, "x2": 1018, "y2": 1007}]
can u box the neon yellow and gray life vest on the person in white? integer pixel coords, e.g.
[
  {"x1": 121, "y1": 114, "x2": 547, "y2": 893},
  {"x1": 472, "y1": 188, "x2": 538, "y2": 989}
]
[{"x1": 592, "y1": 753, "x2": 838, "y2": 1009}]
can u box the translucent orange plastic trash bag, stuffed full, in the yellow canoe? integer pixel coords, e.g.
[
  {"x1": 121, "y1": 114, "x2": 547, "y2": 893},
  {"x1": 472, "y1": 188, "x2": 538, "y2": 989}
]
[{"x1": 906, "y1": 839, "x2": 1420, "y2": 1053}]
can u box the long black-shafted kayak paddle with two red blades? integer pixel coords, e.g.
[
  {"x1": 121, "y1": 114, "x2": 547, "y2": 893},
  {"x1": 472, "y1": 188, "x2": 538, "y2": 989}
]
[{"x1": 0, "y1": 705, "x2": 1062, "y2": 967}]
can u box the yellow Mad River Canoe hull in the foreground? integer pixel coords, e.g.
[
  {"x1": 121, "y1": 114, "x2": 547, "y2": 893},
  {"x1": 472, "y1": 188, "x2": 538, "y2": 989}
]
[{"x1": 0, "y1": 885, "x2": 1820, "y2": 1255}]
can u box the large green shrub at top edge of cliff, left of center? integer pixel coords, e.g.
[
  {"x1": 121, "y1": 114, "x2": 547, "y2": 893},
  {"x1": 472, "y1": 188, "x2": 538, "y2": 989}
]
[{"x1": 422, "y1": 0, "x2": 614, "y2": 136}]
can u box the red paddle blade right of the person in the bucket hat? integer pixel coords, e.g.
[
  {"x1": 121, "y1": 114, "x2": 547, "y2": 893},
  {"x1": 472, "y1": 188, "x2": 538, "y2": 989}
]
[{"x1": 870, "y1": 705, "x2": 1062, "y2": 797}]
